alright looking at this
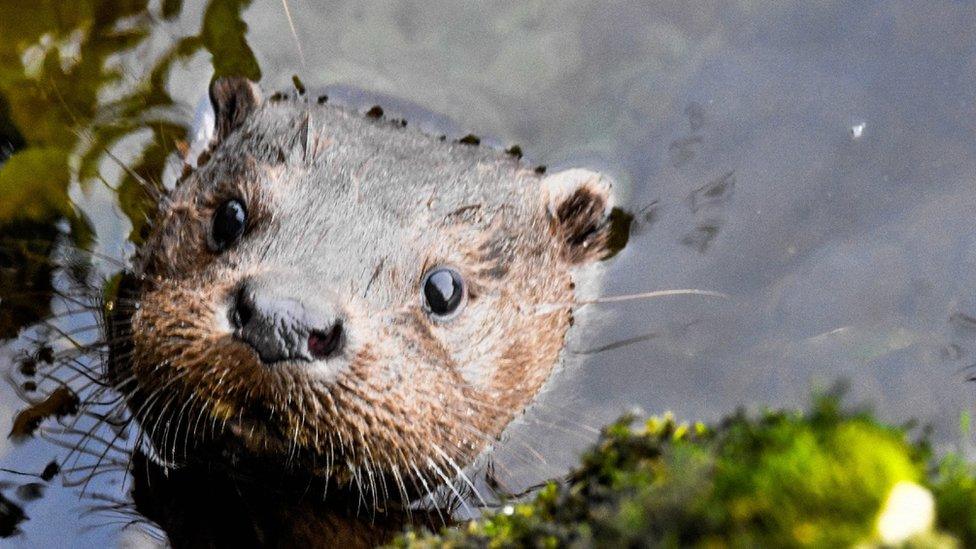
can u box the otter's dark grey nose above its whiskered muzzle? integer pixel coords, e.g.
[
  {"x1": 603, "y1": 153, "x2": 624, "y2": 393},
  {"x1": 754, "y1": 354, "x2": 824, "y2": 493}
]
[{"x1": 229, "y1": 282, "x2": 344, "y2": 364}]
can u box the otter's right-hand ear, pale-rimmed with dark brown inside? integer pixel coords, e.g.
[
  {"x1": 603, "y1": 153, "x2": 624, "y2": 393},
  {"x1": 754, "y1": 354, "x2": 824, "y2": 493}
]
[{"x1": 542, "y1": 169, "x2": 613, "y2": 265}]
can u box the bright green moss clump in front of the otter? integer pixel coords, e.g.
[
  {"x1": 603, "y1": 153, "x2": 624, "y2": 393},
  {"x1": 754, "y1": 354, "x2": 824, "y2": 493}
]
[{"x1": 396, "y1": 396, "x2": 976, "y2": 547}]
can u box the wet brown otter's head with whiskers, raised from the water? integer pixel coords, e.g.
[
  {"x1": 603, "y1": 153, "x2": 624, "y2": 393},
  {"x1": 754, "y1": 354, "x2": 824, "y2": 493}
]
[{"x1": 119, "y1": 80, "x2": 609, "y2": 494}]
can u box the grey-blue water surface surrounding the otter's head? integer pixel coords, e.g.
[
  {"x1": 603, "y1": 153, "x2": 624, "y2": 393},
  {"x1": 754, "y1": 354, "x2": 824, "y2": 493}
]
[{"x1": 0, "y1": 0, "x2": 976, "y2": 546}]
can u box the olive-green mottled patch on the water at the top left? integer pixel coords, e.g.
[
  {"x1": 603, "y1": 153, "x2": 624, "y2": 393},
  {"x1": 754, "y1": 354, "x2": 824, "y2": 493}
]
[{"x1": 0, "y1": 0, "x2": 261, "y2": 338}]
